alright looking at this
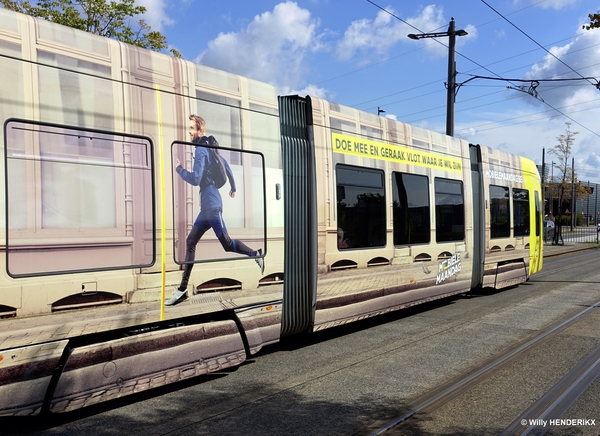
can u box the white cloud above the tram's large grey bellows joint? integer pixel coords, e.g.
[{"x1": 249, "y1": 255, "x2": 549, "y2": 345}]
[{"x1": 196, "y1": 1, "x2": 322, "y2": 91}]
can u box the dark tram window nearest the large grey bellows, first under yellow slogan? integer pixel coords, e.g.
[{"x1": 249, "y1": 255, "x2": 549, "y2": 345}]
[{"x1": 336, "y1": 165, "x2": 386, "y2": 249}]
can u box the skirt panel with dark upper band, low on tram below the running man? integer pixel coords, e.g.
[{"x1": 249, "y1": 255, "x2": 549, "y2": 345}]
[{"x1": 50, "y1": 321, "x2": 246, "y2": 412}]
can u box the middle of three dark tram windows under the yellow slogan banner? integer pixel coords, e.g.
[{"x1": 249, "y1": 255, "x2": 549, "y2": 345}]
[{"x1": 392, "y1": 173, "x2": 431, "y2": 245}]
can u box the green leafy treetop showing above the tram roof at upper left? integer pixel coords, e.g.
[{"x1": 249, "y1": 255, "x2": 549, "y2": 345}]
[{"x1": 0, "y1": 0, "x2": 181, "y2": 58}]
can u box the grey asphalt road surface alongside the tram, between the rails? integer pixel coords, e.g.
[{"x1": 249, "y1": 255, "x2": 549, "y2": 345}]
[{"x1": 0, "y1": 251, "x2": 600, "y2": 436}]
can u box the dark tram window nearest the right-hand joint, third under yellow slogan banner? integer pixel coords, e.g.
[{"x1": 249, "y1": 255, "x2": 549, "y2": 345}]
[{"x1": 435, "y1": 179, "x2": 465, "y2": 242}]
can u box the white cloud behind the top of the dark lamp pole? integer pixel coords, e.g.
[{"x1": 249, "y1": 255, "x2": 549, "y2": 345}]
[{"x1": 336, "y1": 5, "x2": 477, "y2": 60}]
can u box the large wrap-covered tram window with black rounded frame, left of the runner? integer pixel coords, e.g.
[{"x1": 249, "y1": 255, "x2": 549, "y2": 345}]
[{"x1": 4, "y1": 120, "x2": 156, "y2": 277}]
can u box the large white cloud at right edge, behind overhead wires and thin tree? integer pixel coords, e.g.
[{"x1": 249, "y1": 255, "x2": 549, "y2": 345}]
[{"x1": 456, "y1": 25, "x2": 600, "y2": 175}]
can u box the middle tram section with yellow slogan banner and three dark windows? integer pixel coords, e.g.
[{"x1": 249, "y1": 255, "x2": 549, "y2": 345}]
[{"x1": 311, "y1": 97, "x2": 473, "y2": 329}]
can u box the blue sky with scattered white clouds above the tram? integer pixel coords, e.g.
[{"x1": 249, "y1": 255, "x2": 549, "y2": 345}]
[{"x1": 102, "y1": 0, "x2": 600, "y2": 182}]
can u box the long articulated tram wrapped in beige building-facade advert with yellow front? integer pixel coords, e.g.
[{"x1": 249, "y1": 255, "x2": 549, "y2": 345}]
[{"x1": 0, "y1": 9, "x2": 543, "y2": 416}]
